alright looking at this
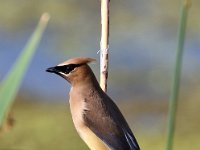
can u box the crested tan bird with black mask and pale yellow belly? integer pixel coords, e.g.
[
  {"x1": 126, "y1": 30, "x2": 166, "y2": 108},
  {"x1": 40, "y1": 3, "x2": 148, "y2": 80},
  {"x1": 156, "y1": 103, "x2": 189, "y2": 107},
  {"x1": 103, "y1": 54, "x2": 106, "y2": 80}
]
[{"x1": 46, "y1": 57, "x2": 140, "y2": 150}]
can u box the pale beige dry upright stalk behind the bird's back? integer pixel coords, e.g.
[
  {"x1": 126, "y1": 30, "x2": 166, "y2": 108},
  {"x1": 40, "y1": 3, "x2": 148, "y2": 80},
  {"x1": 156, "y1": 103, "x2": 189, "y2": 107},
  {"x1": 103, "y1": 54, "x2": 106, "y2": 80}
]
[{"x1": 100, "y1": 0, "x2": 110, "y2": 92}]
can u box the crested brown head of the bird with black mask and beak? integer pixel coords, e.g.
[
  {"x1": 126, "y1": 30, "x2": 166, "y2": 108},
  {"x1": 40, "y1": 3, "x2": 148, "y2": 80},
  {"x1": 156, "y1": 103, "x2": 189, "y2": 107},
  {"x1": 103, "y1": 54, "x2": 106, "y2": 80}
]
[{"x1": 46, "y1": 57, "x2": 95, "y2": 84}]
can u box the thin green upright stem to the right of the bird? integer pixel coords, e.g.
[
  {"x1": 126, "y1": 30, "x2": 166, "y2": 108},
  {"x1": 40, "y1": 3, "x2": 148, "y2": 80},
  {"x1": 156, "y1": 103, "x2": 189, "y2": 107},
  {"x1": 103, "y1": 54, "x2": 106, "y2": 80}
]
[{"x1": 166, "y1": 0, "x2": 191, "y2": 150}]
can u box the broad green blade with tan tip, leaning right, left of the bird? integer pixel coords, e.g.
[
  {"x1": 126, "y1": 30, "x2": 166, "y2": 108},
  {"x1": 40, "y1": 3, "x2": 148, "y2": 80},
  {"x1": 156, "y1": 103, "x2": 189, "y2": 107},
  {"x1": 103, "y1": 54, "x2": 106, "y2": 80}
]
[{"x1": 0, "y1": 13, "x2": 49, "y2": 127}]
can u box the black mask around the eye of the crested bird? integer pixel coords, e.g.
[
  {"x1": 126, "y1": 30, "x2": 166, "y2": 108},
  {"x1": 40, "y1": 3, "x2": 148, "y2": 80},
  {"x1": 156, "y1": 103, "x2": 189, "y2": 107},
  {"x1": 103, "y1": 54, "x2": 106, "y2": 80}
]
[{"x1": 55, "y1": 64, "x2": 81, "y2": 74}]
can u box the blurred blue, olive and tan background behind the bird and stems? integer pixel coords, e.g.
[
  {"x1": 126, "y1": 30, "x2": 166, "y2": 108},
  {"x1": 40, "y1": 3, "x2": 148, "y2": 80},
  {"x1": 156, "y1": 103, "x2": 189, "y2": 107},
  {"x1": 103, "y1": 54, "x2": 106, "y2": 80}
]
[{"x1": 0, "y1": 0, "x2": 200, "y2": 150}]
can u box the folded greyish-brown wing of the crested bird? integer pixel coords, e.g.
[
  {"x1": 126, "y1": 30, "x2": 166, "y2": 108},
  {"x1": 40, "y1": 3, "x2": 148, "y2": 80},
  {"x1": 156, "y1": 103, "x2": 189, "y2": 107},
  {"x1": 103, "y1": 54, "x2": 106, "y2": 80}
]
[{"x1": 84, "y1": 95, "x2": 140, "y2": 150}]
